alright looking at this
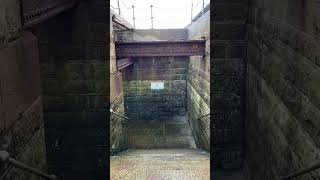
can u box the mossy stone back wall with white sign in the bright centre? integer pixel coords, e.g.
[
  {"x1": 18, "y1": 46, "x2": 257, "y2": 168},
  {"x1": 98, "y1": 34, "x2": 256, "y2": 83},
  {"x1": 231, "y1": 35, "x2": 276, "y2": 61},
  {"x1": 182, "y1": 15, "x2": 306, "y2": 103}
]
[{"x1": 119, "y1": 29, "x2": 195, "y2": 148}]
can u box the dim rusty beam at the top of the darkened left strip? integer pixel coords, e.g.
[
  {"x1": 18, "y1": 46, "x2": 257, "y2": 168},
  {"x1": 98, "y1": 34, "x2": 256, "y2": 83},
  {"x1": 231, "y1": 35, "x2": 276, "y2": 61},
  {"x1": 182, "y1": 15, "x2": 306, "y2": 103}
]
[{"x1": 21, "y1": 0, "x2": 79, "y2": 28}]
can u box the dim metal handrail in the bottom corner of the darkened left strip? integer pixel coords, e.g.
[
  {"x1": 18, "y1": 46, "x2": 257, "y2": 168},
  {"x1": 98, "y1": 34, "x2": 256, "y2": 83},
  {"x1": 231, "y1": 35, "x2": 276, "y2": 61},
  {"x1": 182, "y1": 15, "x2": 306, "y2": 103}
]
[{"x1": 0, "y1": 151, "x2": 58, "y2": 180}]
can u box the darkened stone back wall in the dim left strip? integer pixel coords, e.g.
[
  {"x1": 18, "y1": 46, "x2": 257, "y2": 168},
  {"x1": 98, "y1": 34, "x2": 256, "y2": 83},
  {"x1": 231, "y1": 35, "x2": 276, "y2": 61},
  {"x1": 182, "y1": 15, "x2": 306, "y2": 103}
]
[{"x1": 33, "y1": 0, "x2": 109, "y2": 180}]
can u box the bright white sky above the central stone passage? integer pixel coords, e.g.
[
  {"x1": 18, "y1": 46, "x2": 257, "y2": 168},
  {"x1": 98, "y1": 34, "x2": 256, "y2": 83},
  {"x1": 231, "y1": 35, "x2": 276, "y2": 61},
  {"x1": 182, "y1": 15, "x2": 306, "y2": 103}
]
[{"x1": 110, "y1": 0, "x2": 210, "y2": 29}]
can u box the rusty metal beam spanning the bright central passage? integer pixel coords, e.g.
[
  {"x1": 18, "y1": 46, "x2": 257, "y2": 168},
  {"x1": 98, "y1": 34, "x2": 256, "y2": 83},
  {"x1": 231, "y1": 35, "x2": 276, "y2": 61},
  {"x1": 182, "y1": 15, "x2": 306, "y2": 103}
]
[{"x1": 115, "y1": 40, "x2": 206, "y2": 58}]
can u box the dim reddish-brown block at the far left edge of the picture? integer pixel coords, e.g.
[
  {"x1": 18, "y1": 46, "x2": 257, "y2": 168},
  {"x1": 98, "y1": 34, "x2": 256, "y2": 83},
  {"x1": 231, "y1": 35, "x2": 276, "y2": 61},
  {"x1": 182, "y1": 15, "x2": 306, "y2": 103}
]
[{"x1": 0, "y1": 32, "x2": 40, "y2": 127}]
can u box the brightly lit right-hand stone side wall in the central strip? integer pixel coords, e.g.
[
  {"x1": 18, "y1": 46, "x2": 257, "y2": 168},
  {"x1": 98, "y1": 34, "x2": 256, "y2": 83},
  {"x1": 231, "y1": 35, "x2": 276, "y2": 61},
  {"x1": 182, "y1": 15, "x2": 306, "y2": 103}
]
[{"x1": 187, "y1": 8, "x2": 210, "y2": 151}]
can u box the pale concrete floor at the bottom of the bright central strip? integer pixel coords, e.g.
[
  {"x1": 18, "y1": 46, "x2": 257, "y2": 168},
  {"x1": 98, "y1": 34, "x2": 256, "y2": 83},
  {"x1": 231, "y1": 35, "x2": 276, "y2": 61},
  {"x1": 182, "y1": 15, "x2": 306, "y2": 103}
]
[{"x1": 110, "y1": 149, "x2": 210, "y2": 180}]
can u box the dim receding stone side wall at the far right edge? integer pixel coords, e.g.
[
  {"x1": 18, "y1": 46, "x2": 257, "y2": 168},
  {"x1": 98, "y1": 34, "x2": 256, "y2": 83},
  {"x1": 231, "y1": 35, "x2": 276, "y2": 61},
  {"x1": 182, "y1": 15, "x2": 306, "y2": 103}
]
[{"x1": 246, "y1": 0, "x2": 320, "y2": 180}]
